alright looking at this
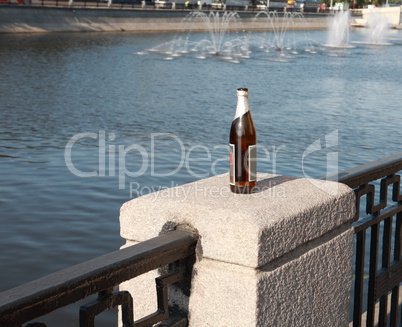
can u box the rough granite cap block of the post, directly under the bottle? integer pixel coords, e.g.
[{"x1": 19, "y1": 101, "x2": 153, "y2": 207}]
[{"x1": 120, "y1": 174, "x2": 355, "y2": 268}]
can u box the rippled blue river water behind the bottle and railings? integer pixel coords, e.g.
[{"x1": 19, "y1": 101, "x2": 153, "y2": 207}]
[{"x1": 0, "y1": 23, "x2": 402, "y2": 325}]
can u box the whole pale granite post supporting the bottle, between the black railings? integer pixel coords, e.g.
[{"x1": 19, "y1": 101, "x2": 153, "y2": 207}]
[{"x1": 120, "y1": 174, "x2": 355, "y2": 327}]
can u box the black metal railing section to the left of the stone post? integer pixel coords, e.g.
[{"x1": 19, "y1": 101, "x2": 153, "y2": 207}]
[{"x1": 0, "y1": 230, "x2": 198, "y2": 327}]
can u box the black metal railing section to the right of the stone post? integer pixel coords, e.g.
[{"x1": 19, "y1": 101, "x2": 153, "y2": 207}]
[{"x1": 329, "y1": 153, "x2": 402, "y2": 327}]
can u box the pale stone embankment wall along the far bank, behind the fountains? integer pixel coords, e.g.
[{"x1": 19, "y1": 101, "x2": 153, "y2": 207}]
[{"x1": 0, "y1": 6, "x2": 327, "y2": 33}]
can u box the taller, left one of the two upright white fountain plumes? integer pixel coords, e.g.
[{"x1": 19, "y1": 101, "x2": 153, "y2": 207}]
[{"x1": 325, "y1": 11, "x2": 350, "y2": 48}]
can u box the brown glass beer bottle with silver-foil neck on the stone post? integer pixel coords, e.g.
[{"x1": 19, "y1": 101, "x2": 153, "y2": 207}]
[{"x1": 229, "y1": 88, "x2": 257, "y2": 193}]
